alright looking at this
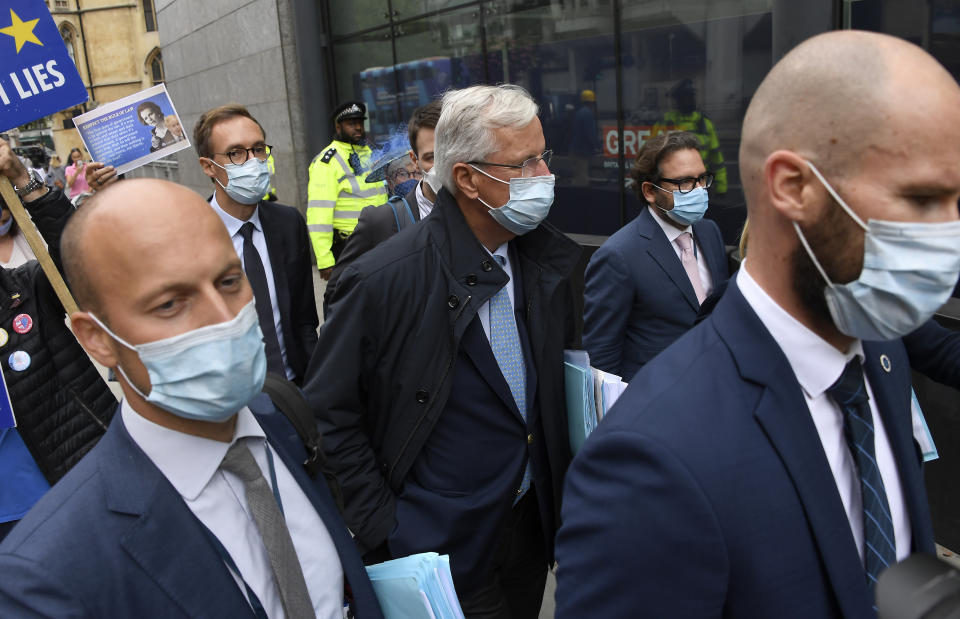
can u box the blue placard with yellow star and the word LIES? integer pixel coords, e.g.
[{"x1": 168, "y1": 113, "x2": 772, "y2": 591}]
[{"x1": 0, "y1": 0, "x2": 87, "y2": 131}]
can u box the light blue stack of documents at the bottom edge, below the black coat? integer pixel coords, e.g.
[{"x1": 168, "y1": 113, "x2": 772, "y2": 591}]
[{"x1": 367, "y1": 552, "x2": 464, "y2": 619}]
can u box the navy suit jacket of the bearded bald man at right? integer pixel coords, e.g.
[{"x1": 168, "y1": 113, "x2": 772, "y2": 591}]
[{"x1": 557, "y1": 282, "x2": 934, "y2": 619}]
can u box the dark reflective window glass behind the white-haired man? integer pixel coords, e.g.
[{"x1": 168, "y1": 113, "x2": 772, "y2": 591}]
[{"x1": 330, "y1": 0, "x2": 776, "y2": 242}]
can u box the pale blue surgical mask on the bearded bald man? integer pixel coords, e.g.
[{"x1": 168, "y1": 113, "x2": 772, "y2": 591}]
[{"x1": 793, "y1": 161, "x2": 960, "y2": 340}]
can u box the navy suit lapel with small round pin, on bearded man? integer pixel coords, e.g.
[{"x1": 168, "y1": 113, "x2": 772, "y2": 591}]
[{"x1": 863, "y1": 342, "x2": 935, "y2": 554}]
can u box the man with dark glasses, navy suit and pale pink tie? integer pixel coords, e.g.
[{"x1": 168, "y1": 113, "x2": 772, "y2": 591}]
[{"x1": 583, "y1": 132, "x2": 729, "y2": 382}]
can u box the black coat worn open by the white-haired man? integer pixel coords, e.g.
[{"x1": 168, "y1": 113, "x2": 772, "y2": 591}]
[{"x1": 304, "y1": 190, "x2": 581, "y2": 549}]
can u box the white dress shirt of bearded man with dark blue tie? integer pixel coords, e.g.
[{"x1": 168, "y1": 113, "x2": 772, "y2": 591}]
[{"x1": 737, "y1": 261, "x2": 913, "y2": 561}]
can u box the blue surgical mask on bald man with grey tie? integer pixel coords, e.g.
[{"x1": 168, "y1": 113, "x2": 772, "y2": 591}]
[{"x1": 90, "y1": 301, "x2": 267, "y2": 421}]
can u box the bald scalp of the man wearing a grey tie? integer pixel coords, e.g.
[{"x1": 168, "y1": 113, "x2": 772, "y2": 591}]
[{"x1": 61, "y1": 179, "x2": 232, "y2": 314}]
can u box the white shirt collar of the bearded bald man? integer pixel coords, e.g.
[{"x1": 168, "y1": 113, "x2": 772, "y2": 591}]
[{"x1": 737, "y1": 260, "x2": 863, "y2": 398}]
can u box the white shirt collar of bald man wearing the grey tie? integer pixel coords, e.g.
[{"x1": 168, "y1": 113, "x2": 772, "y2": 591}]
[{"x1": 120, "y1": 399, "x2": 266, "y2": 501}]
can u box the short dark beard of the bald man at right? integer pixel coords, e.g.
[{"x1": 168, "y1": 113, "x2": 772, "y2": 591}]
[{"x1": 790, "y1": 198, "x2": 863, "y2": 324}]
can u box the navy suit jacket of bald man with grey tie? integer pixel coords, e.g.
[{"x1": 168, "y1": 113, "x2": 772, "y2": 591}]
[{"x1": 0, "y1": 395, "x2": 382, "y2": 618}]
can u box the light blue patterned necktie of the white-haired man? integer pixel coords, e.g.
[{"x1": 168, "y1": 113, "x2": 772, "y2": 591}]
[{"x1": 490, "y1": 255, "x2": 531, "y2": 503}]
